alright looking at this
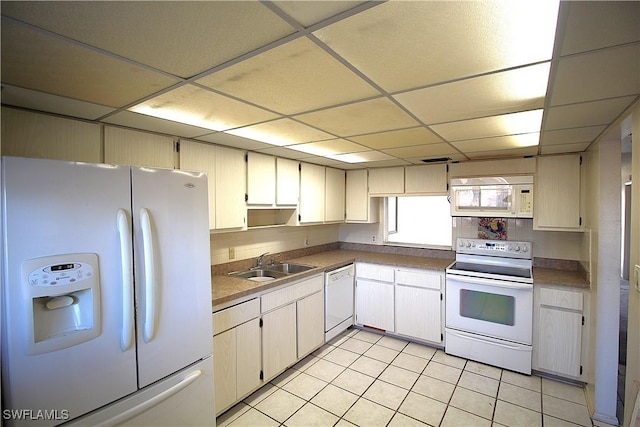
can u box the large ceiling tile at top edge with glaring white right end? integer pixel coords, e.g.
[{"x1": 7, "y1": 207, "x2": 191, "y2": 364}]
[{"x1": 314, "y1": 1, "x2": 558, "y2": 92}]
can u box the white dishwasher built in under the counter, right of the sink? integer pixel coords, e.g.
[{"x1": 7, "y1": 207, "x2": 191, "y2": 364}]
[{"x1": 324, "y1": 264, "x2": 355, "y2": 341}]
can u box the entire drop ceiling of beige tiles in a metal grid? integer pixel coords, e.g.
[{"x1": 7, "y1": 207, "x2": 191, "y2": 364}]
[{"x1": 0, "y1": 0, "x2": 640, "y2": 169}]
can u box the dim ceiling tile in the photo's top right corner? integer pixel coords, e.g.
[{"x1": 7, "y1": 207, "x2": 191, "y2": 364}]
[{"x1": 561, "y1": 1, "x2": 640, "y2": 56}]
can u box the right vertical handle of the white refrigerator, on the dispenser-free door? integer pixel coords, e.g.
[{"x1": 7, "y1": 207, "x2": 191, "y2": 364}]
[{"x1": 140, "y1": 208, "x2": 155, "y2": 342}]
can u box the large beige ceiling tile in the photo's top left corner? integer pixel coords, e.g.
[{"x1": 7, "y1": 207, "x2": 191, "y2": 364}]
[{"x1": 2, "y1": 1, "x2": 294, "y2": 78}]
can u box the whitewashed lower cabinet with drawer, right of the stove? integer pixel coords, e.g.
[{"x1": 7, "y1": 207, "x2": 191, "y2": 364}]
[{"x1": 533, "y1": 286, "x2": 586, "y2": 379}]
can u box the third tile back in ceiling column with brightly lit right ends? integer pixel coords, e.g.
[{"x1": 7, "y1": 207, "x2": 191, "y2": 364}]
[{"x1": 431, "y1": 110, "x2": 542, "y2": 141}]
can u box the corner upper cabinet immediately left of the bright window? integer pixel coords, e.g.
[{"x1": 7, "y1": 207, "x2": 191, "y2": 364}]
[{"x1": 345, "y1": 169, "x2": 380, "y2": 223}]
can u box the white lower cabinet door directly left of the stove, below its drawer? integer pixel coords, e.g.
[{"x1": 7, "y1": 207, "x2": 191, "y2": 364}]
[{"x1": 396, "y1": 286, "x2": 442, "y2": 343}]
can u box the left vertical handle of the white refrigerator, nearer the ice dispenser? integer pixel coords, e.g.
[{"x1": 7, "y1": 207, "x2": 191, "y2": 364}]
[{"x1": 117, "y1": 209, "x2": 134, "y2": 351}]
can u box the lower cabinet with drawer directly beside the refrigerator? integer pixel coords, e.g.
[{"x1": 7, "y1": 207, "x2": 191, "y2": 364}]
[{"x1": 213, "y1": 298, "x2": 262, "y2": 415}]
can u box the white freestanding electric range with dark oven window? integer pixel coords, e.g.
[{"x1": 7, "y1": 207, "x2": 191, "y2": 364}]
[{"x1": 445, "y1": 238, "x2": 533, "y2": 374}]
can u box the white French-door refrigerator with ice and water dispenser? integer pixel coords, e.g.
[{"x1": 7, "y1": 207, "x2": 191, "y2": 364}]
[{"x1": 2, "y1": 157, "x2": 215, "y2": 426}]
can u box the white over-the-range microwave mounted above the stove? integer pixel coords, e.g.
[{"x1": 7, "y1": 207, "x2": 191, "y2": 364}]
[{"x1": 450, "y1": 175, "x2": 533, "y2": 218}]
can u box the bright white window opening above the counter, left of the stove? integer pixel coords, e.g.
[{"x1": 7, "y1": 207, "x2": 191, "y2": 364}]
[{"x1": 385, "y1": 196, "x2": 452, "y2": 247}]
